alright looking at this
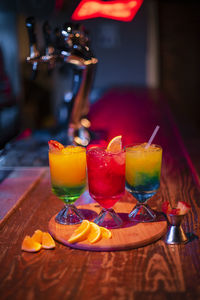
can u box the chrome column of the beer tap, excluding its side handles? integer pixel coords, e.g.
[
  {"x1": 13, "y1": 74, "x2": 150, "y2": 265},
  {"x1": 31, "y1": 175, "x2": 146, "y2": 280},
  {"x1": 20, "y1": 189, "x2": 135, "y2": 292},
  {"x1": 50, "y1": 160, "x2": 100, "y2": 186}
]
[{"x1": 62, "y1": 23, "x2": 98, "y2": 146}]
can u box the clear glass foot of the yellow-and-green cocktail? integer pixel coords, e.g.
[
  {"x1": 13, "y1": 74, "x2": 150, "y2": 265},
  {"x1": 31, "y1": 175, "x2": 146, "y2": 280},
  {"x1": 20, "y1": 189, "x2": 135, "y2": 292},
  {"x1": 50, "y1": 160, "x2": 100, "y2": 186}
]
[{"x1": 55, "y1": 204, "x2": 84, "y2": 225}]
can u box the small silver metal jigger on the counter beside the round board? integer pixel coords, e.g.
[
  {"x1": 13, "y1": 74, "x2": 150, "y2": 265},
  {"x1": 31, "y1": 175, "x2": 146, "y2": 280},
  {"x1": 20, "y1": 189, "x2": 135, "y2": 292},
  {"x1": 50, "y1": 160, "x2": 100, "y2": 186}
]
[{"x1": 165, "y1": 215, "x2": 188, "y2": 244}]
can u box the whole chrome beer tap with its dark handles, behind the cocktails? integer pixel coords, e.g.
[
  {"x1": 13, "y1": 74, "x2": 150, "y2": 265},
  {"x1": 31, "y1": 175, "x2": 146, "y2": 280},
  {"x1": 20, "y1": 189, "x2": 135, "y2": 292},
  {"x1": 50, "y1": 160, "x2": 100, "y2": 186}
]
[{"x1": 26, "y1": 17, "x2": 98, "y2": 146}]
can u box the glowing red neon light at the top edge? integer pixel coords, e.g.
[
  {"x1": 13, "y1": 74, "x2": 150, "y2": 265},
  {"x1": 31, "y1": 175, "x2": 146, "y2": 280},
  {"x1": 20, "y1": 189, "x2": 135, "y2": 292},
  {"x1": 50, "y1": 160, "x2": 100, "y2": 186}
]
[{"x1": 72, "y1": 0, "x2": 143, "y2": 22}]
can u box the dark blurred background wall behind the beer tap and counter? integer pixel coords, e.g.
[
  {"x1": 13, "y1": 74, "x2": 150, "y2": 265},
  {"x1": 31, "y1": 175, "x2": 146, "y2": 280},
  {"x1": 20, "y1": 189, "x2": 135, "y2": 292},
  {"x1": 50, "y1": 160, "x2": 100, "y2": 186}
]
[{"x1": 0, "y1": 0, "x2": 200, "y2": 149}]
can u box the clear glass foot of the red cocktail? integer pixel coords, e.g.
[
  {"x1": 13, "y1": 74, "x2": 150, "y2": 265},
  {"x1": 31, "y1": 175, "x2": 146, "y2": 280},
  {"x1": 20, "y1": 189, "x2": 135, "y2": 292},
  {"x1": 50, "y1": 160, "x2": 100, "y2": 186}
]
[{"x1": 94, "y1": 208, "x2": 123, "y2": 228}]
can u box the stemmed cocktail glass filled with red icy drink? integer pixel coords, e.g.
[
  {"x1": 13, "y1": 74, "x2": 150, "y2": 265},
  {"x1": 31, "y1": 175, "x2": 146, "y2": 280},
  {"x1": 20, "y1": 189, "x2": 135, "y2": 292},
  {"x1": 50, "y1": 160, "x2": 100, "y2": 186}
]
[{"x1": 87, "y1": 147, "x2": 125, "y2": 228}]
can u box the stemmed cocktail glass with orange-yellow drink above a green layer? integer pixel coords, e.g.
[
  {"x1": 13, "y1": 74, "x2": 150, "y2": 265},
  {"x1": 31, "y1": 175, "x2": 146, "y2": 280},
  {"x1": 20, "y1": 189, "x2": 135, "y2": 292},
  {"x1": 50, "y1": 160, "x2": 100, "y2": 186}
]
[{"x1": 49, "y1": 146, "x2": 86, "y2": 225}]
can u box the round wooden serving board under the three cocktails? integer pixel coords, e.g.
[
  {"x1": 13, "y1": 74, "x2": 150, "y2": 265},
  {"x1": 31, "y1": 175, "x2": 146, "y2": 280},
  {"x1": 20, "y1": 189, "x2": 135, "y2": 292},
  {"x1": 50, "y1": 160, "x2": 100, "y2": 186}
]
[{"x1": 49, "y1": 202, "x2": 167, "y2": 251}]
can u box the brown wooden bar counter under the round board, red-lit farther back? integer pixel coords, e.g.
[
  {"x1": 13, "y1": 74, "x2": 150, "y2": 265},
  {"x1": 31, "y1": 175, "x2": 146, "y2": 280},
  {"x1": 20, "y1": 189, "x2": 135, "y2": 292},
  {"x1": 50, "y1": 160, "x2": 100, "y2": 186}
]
[{"x1": 0, "y1": 91, "x2": 200, "y2": 300}]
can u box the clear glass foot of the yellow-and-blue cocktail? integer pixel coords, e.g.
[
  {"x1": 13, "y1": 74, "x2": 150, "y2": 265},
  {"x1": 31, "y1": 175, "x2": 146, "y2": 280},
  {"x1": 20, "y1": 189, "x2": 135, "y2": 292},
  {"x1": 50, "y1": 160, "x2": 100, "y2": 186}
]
[{"x1": 128, "y1": 203, "x2": 156, "y2": 222}]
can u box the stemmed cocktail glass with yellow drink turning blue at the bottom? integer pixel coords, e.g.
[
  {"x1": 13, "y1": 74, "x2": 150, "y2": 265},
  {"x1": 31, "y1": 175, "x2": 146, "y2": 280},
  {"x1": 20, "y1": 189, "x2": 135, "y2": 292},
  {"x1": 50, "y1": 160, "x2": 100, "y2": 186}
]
[{"x1": 125, "y1": 143, "x2": 162, "y2": 222}]
